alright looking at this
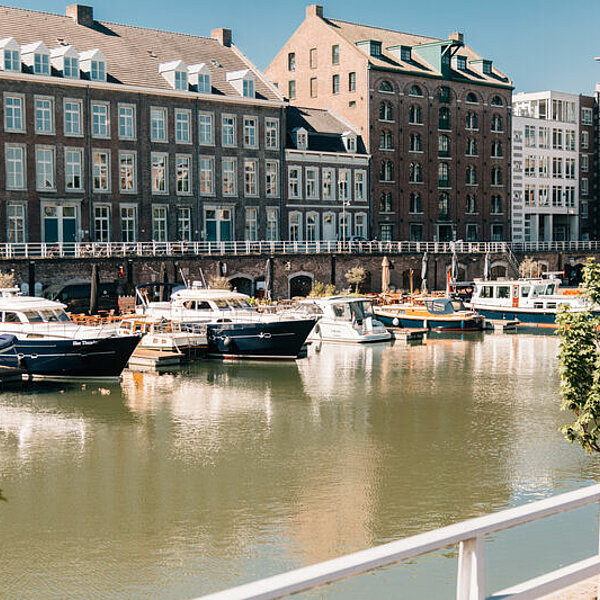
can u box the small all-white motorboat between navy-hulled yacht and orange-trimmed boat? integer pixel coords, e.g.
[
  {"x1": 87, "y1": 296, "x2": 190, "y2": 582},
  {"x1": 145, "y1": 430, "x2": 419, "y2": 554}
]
[{"x1": 291, "y1": 296, "x2": 392, "y2": 343}]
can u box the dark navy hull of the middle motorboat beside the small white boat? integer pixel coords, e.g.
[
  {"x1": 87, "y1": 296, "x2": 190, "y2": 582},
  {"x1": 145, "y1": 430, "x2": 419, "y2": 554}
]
[{"x1": 206, "y1": 319, "x2": 316, "y2": 360}]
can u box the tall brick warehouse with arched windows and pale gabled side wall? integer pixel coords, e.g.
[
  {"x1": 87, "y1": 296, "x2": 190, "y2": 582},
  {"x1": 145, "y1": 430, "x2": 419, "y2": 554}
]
[{"x1": 266, "y1": 5, "x2": 512, "y2": 241}]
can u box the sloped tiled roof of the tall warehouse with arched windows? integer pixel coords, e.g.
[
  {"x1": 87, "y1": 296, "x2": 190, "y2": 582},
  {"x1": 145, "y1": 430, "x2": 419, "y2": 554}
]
[{"x1": 323, "y1": 19, "x2": 512, "y2": 86}]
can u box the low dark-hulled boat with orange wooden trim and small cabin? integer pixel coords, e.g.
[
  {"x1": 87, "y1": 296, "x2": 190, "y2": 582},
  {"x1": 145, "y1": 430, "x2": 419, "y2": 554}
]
[{"x1": 375, "y1": 298, "x2": 484, "y2": 331}]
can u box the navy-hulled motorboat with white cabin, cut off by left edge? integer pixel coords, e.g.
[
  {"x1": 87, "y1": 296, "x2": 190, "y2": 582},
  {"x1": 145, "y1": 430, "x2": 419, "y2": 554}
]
[{"x1": 0, "y1": 289, "x2": 140, "y2": 378}]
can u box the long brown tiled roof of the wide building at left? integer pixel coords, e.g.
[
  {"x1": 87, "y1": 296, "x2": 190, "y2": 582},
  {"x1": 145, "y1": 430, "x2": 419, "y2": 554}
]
[{"x1": 0, "y1": 6, "x2": 280, "y2": 100}]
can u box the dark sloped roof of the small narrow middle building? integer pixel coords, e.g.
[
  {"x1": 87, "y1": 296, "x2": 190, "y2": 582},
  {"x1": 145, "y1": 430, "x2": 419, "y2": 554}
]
[{"x1": 286, "y1": 106, "x2": 365, "y2": 154}]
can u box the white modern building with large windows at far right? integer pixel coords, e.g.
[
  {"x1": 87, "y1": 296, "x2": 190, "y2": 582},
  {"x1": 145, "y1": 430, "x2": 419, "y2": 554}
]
[{"x1": 512, "y1": 91, "x2": 593, "y2": 242}]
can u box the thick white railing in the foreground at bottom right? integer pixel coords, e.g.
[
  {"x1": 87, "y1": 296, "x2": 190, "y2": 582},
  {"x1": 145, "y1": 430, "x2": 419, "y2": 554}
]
[{"x1": 198, "y1": 484, "x2": 600, "y2": 600}]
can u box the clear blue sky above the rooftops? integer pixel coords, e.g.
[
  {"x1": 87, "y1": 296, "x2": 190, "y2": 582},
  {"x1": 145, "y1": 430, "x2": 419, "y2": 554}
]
[{"x1": 7, "y1": 0, "x2": 600, "y2": 94}]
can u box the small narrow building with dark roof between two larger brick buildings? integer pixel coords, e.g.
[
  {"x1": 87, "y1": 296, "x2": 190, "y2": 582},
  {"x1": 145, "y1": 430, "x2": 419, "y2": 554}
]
[{"x1": 284, "y1": 107, "x2": 370, "y2": 242}]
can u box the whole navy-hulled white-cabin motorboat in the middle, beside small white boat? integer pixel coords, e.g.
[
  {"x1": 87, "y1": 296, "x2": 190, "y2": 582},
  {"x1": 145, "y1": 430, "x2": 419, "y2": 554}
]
[{"x1": 136, "y1": 282, "x2": 316, "y2": 360}]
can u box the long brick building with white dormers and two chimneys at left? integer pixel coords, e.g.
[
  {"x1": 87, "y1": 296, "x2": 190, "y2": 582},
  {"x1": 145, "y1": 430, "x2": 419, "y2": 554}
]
[{"x1": 0, "y1": 5, "x2": 285, "y2": 242}]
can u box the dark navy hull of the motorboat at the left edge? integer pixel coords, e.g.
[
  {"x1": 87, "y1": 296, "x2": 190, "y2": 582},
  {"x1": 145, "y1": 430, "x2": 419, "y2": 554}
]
[{"x1": 0, "y1": 336, "x2": 140, "y2": 377}]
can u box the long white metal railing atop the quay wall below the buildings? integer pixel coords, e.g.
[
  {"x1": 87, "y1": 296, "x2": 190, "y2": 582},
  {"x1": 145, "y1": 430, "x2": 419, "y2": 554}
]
[{"x1": 0, "y1": 241, "x2": 600, "y2": 259}]
